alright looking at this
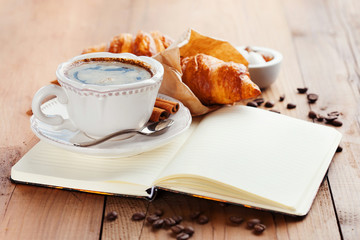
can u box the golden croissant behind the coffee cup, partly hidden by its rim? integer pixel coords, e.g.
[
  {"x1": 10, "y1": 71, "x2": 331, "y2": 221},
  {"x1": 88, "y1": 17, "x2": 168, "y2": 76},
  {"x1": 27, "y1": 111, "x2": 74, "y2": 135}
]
[{"x1": 82, "y1": 31, "x2": 174, "y2": 57}]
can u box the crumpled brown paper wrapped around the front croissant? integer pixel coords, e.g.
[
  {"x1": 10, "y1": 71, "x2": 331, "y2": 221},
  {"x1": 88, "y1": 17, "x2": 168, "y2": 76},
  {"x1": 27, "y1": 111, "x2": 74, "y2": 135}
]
[{"x1": 154, "y1": 29, "x2": 248, "y2": 116}]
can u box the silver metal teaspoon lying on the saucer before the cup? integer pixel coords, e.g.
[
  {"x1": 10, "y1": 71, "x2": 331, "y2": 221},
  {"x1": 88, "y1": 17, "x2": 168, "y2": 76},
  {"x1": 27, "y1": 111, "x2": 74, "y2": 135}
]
[{"x1": 73, "y1": 119, "x2": 174, "y2": 147}]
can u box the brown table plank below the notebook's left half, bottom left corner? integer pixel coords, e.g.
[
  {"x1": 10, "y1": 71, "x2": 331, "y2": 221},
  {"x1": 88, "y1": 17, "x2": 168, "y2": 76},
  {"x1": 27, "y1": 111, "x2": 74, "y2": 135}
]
[{"x1": 0, "y1": 185, "x2": 103, "y2": 239}]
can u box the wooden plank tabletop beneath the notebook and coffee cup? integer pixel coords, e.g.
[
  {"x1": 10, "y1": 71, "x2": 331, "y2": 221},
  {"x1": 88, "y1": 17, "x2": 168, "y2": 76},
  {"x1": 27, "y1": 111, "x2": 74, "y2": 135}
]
[{"x1": 0, "y1": 0, "x2": 360, "y2": 239}]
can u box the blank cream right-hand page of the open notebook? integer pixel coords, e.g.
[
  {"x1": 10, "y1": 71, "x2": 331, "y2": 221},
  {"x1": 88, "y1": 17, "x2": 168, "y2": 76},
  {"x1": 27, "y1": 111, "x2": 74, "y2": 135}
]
[{"x1": 157, "y1": 106, "x2": 341, "y2": 210}]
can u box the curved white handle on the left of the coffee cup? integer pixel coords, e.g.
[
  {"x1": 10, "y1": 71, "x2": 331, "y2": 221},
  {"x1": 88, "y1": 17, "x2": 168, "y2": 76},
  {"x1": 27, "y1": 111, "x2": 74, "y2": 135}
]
[{"x1": 31, "y1": 84, "x2": 78, "y2": 131}]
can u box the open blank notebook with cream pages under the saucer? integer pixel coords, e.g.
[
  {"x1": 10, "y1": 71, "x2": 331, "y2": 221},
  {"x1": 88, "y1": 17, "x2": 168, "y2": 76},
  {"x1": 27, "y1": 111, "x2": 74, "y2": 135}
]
[{"x1": 11, "y1": 106, "x2": 341, "y2": 215}]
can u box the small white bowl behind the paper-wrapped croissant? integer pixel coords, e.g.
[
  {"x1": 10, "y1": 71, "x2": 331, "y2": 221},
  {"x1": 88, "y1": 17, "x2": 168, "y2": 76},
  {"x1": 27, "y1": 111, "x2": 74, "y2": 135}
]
[{"x1": 236, "y1": 46, "x2": 283, "y2": 89}]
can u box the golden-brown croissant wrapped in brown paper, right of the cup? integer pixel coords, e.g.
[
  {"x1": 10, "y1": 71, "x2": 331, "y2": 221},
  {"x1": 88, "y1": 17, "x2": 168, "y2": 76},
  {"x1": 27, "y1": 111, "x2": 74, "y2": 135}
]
[{"x1": 181, "y1": 54, "x2": 261, "y2": 105}]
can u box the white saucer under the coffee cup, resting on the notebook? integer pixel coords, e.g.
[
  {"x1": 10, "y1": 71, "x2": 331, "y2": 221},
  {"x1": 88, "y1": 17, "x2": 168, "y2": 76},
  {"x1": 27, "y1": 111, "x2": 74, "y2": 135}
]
[{"x1": 30, "y1": 94, "x2": 192, "y2": 157}]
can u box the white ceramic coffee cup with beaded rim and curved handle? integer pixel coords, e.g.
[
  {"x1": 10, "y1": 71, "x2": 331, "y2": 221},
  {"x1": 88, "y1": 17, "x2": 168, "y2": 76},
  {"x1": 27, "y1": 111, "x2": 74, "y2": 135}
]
[{"x1": 32, "y1": 52, "x2": 164, "y2": 137}]
